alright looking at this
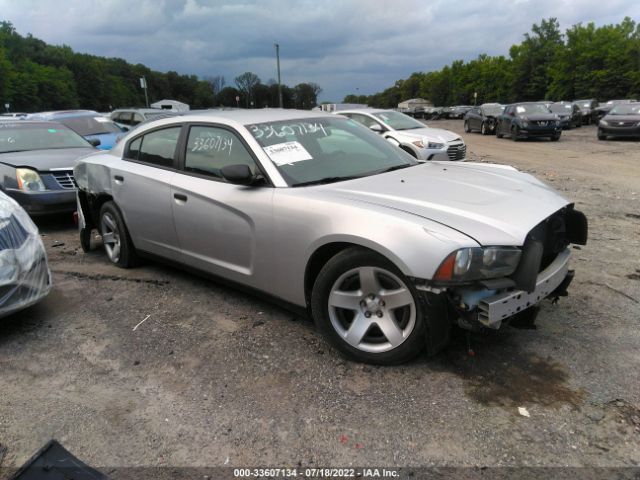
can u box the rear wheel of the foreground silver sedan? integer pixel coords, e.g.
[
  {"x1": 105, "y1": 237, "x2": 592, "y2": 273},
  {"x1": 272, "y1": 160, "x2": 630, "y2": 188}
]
[{"x1": 99, "y1": 201, "x2": 138, "y2": 268}]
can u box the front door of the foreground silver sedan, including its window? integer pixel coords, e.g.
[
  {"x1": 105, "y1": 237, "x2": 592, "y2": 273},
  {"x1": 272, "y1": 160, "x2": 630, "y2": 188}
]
[{"x1": 171, "y1": 124, "x2": 274, "y2": 289}]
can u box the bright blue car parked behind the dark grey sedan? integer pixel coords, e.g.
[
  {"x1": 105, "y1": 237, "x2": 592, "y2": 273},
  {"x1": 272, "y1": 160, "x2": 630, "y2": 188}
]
[{"x1": 27, "y1": 110, "x2": 124, "y2": 150}]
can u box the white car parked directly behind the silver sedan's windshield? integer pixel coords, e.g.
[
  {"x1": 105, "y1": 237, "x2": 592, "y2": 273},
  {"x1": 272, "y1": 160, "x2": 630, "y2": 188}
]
[{"x1": 336, "y1": 109, "x2": 467, "y2": 161}]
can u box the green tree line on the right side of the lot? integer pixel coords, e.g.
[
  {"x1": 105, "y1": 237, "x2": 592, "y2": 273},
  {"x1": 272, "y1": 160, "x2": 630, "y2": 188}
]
[{"x1": 344, "y1": 17, "x2": 640, "y2": 108}]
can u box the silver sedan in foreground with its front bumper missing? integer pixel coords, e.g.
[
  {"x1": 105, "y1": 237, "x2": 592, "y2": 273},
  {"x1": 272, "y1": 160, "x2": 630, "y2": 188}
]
[{"x1": 75, "y1": 110, "x2": 587, "y2": 364}]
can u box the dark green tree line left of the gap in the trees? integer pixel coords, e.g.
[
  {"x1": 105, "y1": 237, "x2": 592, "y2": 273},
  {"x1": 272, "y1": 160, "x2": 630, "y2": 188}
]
[{"x1": 0, "y1": 21, "x2": 322, "y2": 112}]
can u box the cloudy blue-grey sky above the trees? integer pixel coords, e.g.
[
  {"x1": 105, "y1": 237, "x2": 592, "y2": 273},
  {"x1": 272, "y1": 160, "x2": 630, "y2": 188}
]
[{"x1": 0, "y1": 0, "x2": 640, "y2": 101}]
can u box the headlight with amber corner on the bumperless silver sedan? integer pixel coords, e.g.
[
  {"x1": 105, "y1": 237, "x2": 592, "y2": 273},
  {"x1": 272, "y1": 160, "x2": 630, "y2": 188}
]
[{"x1": 433, "y1": 247, "x2": 522, "y2": 281}]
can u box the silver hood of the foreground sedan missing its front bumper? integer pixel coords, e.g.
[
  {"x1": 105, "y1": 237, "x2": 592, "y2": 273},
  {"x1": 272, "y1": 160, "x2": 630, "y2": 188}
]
[{"x1": 323, "y1": 162, "x2": 569, "y2": 246}]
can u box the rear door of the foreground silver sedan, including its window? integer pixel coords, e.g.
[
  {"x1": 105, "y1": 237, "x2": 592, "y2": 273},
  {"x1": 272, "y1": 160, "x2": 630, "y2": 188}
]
[{"x1": 110, "y1": 125, "x2": 182, "y2": 261}]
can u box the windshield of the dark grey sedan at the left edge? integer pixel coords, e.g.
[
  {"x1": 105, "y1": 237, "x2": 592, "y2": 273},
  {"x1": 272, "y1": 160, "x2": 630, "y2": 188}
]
[{"x1": 0, "y1": 122, "x2": 91, "y2": 153}]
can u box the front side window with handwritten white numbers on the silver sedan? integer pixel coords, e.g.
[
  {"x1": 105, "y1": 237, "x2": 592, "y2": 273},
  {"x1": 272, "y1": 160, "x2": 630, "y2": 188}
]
[{"x1": 184, "y1": 126, "x2": 258, "y2": 178}]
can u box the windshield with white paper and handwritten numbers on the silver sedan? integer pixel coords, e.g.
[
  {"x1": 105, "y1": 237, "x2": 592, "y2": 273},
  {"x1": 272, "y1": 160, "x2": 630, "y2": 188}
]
[{"x1": 247, "y1": 117, "x2": 417, "y2": 187}]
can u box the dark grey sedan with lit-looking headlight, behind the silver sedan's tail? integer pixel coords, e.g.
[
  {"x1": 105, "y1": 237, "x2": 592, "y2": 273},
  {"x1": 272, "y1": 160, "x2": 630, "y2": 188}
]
[{"x1": 0, "y1": 120, "x2": 96, "y2": 215}]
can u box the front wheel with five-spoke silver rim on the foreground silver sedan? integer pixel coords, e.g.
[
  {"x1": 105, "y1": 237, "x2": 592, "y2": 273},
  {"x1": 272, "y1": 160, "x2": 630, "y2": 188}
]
[{"x1": 311, "y1": 247, "x2": 426, "y2": 365}]
